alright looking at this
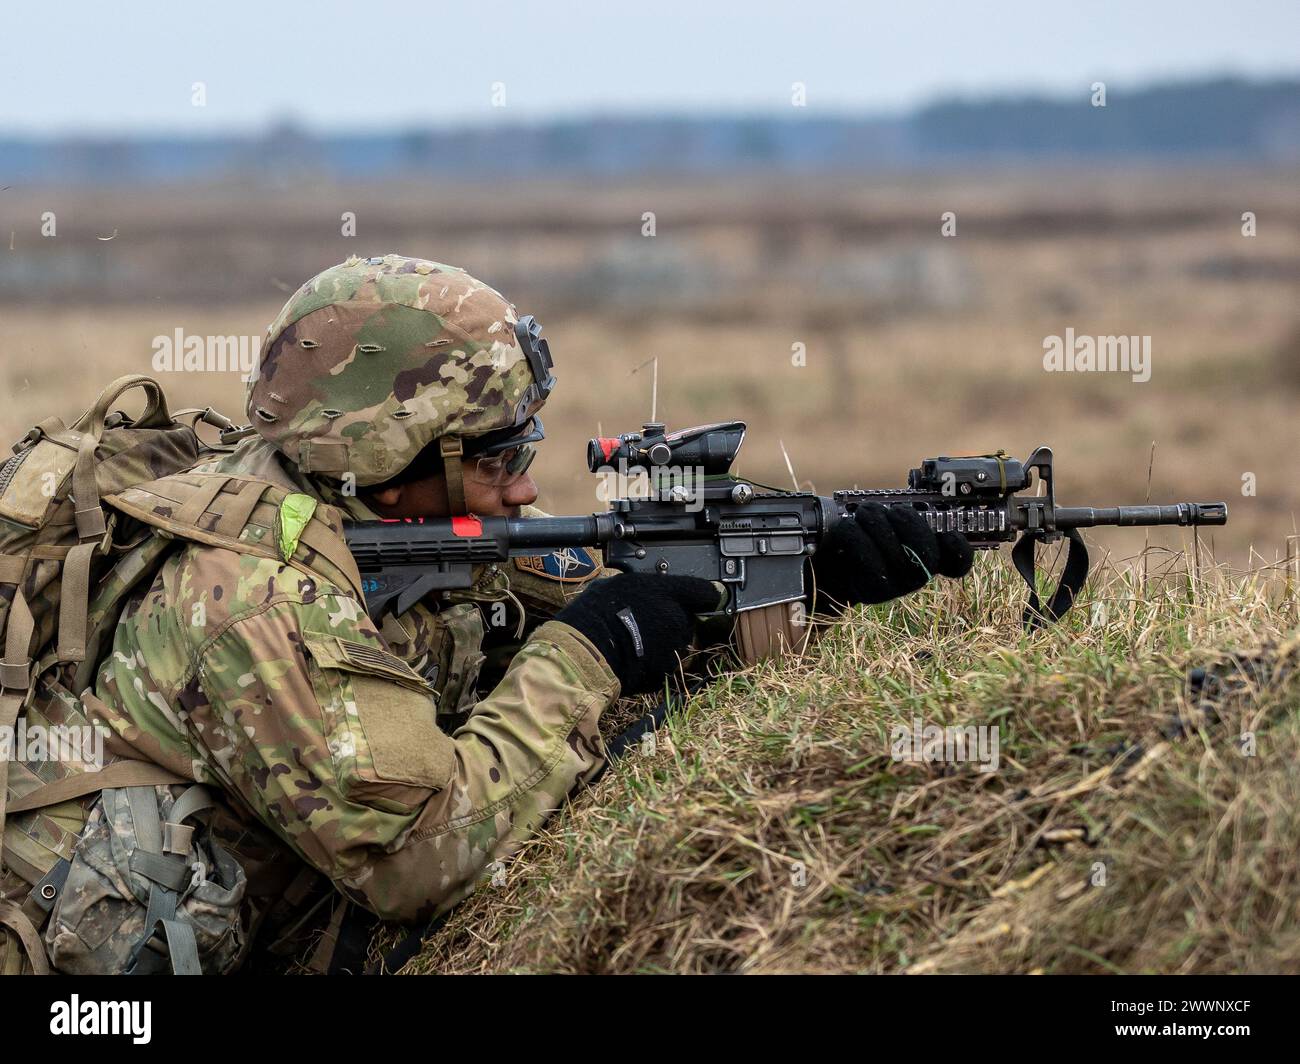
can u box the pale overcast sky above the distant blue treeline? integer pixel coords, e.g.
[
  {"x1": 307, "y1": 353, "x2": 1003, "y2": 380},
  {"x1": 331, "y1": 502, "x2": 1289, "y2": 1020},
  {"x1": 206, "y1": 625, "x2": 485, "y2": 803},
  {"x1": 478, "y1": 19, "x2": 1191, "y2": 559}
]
[{"x1": 0, "y1": 0, "x2": 1300, "y2": 135}]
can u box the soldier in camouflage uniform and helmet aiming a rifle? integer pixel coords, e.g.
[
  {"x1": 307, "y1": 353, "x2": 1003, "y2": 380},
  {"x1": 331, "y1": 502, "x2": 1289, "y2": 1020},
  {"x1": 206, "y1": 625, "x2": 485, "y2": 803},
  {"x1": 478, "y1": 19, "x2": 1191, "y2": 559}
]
[{"x1": 86, "y1": 255, "x2": 970, "y2": 962}]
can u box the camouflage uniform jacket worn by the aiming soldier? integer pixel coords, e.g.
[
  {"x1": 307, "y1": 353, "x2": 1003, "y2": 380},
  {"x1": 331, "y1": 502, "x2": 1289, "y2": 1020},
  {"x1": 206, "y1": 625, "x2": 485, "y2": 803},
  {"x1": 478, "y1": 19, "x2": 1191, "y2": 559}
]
[{"x1": 87, "y1": 438, "x2": 619, "y2": 920}]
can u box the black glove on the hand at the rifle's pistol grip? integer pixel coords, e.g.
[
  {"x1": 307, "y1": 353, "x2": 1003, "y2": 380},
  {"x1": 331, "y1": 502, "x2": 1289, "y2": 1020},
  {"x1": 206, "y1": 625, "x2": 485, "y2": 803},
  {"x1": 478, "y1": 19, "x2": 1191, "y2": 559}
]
[{"x1": 555, "y1": 572, "x2": 722, "y2": 695}]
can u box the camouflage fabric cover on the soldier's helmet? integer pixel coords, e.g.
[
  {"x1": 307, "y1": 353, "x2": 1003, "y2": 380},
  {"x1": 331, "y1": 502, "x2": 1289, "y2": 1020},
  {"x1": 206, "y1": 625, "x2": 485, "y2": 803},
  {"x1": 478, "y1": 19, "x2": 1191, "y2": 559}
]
[{"x1": 247, "y1": 255, "x2": 546, "y2": 486}]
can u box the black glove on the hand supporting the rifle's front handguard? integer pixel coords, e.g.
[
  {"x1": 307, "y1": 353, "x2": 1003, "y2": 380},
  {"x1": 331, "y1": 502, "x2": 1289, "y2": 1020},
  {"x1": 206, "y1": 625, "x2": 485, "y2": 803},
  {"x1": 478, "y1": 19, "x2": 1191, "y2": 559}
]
[{"x1": 813, "y1": 502, "x2": 975, "y2": 611}]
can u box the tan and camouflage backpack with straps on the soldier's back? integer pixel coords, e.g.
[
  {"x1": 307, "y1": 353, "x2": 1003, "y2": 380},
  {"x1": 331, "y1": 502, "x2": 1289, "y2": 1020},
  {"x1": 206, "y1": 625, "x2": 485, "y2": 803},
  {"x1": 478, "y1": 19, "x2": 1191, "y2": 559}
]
[{"x1": 0, "y1": 376, "x2": 361, "y2": 974}]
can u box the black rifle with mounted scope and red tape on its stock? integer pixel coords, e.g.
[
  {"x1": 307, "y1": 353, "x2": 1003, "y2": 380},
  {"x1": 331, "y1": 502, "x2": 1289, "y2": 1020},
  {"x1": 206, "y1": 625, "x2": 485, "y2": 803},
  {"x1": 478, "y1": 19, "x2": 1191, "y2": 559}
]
[{"x1": 346, "y1": 421, "x2": 1227, "y2": 628}]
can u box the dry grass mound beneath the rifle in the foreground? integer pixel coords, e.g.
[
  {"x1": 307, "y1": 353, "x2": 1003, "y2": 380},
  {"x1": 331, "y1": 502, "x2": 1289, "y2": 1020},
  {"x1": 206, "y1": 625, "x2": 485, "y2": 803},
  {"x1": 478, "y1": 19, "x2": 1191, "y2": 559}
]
[{"x1": 406, "y1": 555, "x2": 1300, "y2": 973}]
